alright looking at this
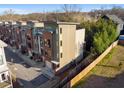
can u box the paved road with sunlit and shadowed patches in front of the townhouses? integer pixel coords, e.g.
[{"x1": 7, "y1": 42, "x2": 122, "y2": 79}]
[{"x1": 5, "y1": 48, "x2": 48, "y2": 88}]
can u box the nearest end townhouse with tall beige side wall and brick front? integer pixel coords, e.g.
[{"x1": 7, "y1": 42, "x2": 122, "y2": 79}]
[{"x1": 42, "y1": 22, "x2": 85, "y2": 72}]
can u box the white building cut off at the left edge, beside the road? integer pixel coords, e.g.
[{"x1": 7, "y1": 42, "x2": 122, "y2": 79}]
[{"x1": 0, "y1": 40, "x2": 12, "y2": 88}]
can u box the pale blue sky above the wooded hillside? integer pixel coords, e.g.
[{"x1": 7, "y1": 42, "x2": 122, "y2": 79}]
[{"x1": 0, "y1": 4, "x2": 124, "y2": 14}]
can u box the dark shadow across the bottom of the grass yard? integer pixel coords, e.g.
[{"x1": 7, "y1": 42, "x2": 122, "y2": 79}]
[{"x1": 79, "y1": 73, "x2": 124, "y2": 88}]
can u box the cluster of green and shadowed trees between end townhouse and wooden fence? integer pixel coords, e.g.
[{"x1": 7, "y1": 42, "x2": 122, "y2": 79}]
[{"x1": 80, "y1": 19, "x2": 118, "y2": 54}]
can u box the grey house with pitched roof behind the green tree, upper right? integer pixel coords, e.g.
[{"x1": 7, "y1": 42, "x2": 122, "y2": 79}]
[{"x1": 102, "y1": 14, "x2": 124, "y2": 34}]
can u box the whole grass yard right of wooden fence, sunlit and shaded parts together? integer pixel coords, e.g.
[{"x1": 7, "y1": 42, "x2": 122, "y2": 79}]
[{"x1": 73, "y1": 45, "x2": 124, "y2": 88}]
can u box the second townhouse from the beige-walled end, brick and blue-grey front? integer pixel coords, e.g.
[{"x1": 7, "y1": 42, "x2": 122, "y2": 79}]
[{"x1": 26, "y1": 20, "x2": 44, "y2": 61}]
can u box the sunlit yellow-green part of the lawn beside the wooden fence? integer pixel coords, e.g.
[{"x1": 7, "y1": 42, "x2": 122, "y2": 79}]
[{"x1": 73, "y1": 45, "x2": 124, "y2": 87}]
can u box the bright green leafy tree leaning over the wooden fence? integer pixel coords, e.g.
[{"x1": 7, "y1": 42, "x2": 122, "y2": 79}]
[{"x1": 93, "y1": 19, "x2": 118, "y2": 54}]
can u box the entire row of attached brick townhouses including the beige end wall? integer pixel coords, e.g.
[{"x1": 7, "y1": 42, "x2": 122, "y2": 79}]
[{"x1": 0, "y1": 21, "x2": 85, "y2": 72}]
